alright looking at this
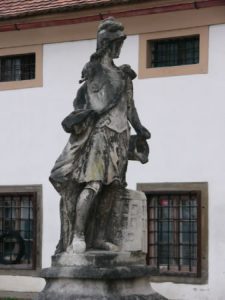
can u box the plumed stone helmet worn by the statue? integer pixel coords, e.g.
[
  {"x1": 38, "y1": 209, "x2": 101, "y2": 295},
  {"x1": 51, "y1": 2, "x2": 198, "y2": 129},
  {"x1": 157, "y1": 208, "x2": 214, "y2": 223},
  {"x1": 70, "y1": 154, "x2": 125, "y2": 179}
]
[{"x1": 97, "y1": 17, "x2": 126, "y2": 50}]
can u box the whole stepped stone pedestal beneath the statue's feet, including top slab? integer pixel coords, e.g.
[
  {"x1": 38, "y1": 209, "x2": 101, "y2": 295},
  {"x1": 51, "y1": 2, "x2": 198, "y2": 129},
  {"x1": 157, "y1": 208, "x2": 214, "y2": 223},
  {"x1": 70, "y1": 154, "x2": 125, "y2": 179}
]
[{"x1": 37, "y1": 251, "x2": 166, "y2": 300}]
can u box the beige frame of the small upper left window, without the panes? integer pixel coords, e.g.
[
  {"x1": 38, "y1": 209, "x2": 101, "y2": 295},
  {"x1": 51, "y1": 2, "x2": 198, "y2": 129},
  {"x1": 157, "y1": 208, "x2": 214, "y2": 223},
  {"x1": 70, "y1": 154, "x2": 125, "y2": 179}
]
[{"x1": 0, "y1": 45, "x2": 43, "y2": 91}]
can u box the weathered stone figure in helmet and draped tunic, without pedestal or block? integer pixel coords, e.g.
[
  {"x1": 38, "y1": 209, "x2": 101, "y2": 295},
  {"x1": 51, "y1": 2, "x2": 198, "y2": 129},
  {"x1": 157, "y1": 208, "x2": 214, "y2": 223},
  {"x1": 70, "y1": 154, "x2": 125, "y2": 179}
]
[{"x1": 50, "y1": 17, "x2": 150, "y2": 254}]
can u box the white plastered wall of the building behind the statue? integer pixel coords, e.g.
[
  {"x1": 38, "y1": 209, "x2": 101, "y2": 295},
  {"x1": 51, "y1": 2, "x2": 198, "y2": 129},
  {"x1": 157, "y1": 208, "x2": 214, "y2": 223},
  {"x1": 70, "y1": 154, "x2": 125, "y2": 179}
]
[{"x1": 0, "y1": 25, "x2": 225, "y2": 300}]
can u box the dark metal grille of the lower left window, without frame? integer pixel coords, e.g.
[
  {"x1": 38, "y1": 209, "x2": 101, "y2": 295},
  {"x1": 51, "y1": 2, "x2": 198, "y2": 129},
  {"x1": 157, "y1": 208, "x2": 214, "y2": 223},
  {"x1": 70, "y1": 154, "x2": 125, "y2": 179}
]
[{"x1": 0, "y1": 193, "x2": 36, "y2": 269}]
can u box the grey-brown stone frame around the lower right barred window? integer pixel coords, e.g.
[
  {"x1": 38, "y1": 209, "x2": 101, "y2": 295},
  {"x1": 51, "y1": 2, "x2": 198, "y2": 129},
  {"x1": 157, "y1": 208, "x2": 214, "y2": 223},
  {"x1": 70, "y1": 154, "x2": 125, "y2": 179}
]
[{"x1": 137, "y1": 182, "x2": 208, "y2": 284}]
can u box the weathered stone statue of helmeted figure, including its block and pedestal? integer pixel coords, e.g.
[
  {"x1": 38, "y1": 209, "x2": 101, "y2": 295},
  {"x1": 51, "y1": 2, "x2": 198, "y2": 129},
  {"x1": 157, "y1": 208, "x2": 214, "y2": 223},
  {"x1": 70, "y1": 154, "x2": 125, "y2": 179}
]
[{"x1": 37, "y1": 17, "x2": 166, "y2": 300}]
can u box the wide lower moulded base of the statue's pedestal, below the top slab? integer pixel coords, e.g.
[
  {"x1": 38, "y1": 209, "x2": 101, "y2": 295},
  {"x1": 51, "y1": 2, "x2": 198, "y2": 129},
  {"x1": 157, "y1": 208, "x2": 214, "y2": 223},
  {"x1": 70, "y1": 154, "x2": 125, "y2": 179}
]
[{"x1": 37, "y1": 266, "x2": 166, "y2": 300}]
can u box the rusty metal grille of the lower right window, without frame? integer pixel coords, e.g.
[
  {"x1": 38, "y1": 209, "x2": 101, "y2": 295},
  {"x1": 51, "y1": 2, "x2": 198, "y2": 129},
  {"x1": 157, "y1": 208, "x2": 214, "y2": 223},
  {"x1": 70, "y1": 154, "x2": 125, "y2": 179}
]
[{"x1": 147, "y1": 192, "x2": 201, "y2": 277}]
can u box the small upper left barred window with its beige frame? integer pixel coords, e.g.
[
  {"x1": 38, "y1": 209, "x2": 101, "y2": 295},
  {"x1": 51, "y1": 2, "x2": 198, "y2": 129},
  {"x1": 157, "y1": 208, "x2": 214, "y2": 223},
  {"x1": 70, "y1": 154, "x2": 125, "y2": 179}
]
[{"x1": 0, "y1": 46, "x2": 43, "y2": 90}]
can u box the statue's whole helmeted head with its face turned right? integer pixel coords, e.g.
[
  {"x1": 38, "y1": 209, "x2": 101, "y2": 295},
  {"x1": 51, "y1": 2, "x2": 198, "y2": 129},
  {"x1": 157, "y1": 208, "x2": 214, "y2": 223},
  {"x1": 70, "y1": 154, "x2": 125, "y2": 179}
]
[{"x1": 97, "y1": 17, "x2": 126, "y2": 58}]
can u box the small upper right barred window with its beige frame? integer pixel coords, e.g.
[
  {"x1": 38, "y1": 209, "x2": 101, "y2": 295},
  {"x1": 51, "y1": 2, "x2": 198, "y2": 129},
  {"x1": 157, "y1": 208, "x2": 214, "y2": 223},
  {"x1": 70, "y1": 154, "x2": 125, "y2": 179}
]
[{"x1": 139, "y1": 27, "x2": 208, "y2": 78}]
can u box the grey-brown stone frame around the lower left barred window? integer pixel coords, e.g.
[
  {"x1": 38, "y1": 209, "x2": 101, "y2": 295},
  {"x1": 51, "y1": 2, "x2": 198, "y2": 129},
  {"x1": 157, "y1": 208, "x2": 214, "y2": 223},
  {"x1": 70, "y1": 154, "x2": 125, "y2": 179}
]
[{"x1": 0, "y1": 185, "x2": 43, "y2": 276}]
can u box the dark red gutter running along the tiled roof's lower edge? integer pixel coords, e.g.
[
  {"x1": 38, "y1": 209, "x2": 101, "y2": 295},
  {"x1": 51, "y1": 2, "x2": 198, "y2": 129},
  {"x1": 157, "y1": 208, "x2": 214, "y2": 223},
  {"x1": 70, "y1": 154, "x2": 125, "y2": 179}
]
[{"x1": 0, "y1": 0, "x2": 225, "y2": 32}]
